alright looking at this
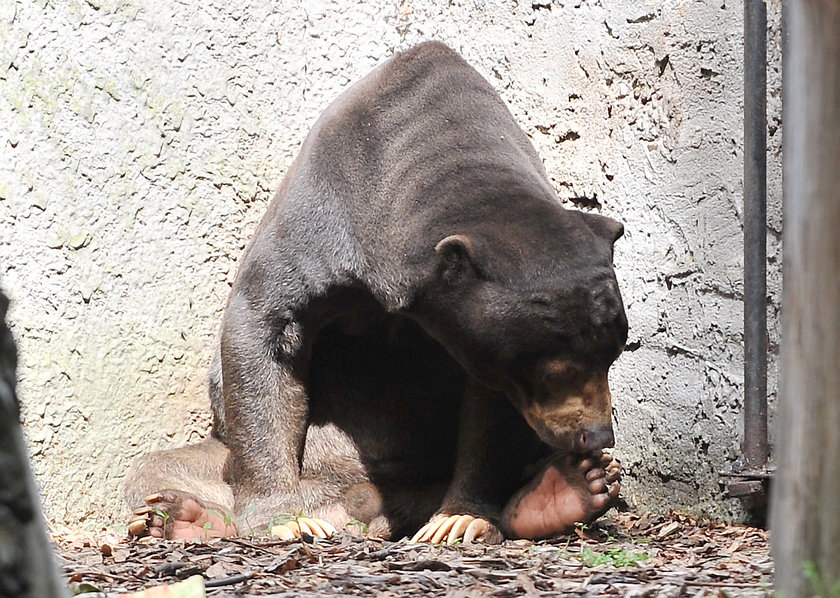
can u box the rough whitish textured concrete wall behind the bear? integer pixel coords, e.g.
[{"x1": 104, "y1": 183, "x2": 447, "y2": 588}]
[{"x1": 0, "y1": 0, "x2": 781, "y2": 526}]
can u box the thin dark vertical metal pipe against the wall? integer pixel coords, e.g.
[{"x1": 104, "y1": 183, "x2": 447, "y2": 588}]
[{"x1": 743, "y1": 0, "x2": 769, "y2": 469}]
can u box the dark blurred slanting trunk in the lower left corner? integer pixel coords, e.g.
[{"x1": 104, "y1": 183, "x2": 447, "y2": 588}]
[{"x1": 0, "y1": 292, "x2": 65, "y2": 598}]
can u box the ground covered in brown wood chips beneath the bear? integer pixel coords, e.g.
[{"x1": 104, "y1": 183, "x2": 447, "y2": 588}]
[{"x1": 55, "y1": 513, "x2": 773, "y2": 598}]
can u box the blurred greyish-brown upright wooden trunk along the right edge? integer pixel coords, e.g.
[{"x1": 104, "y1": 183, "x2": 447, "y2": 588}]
[{"x1": 772, "y1": 0, "x2": 840, "y2": 598}]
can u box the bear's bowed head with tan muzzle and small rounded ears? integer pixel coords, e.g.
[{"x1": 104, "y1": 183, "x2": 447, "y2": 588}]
[{"x1": 419, "y1": 206, "x2": 627, "y2": 453}]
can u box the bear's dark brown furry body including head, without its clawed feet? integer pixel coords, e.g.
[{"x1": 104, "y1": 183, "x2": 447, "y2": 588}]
[{"x1": 126, "y1": 43, "x2": 627, "y2": 535}]
